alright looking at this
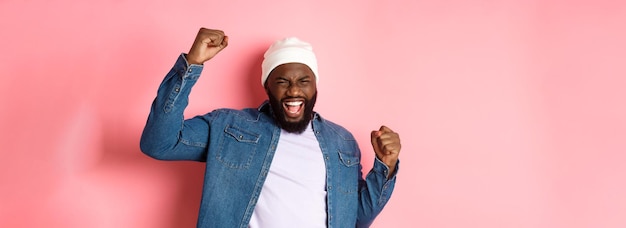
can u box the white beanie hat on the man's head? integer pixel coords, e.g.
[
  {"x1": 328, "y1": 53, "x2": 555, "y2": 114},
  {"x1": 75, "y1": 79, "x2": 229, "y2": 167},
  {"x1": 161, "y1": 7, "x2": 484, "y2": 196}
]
[{"x1": 261, "y1": 37, "x2": 319, "y2": 85}]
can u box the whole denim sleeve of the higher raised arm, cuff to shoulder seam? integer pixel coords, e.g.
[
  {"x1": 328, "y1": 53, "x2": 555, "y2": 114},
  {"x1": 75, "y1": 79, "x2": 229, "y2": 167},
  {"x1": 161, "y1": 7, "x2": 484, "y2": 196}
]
[{"x1": 139, "y1": 54, "x2": 209, "y2": 161}]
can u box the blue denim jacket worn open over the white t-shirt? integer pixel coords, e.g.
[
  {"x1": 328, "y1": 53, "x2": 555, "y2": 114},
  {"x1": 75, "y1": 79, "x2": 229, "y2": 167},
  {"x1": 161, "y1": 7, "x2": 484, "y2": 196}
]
[{"x1": 140, "y1": 54, "x2": 398, "y2": 228}]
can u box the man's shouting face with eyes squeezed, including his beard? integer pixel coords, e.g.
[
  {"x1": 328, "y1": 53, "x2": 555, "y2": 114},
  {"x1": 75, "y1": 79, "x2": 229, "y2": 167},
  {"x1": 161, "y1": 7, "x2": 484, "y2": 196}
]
[{"x1": 265, "y1": 63, "x2": 317, "y2": 133}]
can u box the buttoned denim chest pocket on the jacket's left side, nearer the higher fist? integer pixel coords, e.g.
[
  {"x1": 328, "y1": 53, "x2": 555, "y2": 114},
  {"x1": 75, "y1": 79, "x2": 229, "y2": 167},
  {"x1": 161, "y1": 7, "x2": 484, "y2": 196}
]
[{"x1": 216, "y1": 126, "x2": 261, "y2": 169}]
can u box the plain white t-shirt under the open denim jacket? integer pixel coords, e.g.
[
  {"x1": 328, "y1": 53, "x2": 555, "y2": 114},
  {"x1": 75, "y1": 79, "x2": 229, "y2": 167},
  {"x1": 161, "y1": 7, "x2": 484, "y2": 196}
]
[{"x1": 249, "y1": 124, "x2": 326, "y2": 228}]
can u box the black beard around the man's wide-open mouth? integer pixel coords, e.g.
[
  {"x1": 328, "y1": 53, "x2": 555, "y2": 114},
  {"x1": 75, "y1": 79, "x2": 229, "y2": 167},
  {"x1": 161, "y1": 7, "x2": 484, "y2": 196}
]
[{"x1": 267, "y1": 91, "x2": 317, "y2": 134}]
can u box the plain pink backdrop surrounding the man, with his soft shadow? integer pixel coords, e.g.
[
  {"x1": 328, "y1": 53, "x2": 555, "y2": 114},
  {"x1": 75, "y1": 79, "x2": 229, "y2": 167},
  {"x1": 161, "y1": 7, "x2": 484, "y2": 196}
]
[{"x1": 0, "y1": 0, "x2": 626, "y2": 228}]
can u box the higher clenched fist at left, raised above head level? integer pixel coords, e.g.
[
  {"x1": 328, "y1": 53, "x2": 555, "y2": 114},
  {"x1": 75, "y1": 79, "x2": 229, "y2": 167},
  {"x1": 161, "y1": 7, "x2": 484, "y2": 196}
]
[{"x1": 187, "y1": 28, "x2": 228, "y2": 64}]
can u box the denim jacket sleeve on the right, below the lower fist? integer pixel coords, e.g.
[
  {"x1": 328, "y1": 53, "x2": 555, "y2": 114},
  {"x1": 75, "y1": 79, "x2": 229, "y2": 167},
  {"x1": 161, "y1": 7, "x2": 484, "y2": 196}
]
[{"x1": 356, "y1": 154, "x2": 400, "y2": 227}]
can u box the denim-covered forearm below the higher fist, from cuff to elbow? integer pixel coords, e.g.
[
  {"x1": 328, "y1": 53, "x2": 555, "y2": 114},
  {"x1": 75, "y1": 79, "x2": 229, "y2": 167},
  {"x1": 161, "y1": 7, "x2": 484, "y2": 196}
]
[{"x1": 140, "y1": 54, "x2": 203, "y2": 160}]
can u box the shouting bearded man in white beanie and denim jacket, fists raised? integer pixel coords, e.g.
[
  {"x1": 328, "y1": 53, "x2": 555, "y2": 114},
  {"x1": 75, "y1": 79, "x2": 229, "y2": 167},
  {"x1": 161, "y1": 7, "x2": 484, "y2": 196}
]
[{"x1": 140, "y1": 28, "x2": 400, "y2": 228}]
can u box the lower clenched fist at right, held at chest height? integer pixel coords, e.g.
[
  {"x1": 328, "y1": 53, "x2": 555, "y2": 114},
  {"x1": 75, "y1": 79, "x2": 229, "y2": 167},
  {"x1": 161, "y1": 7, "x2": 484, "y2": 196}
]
[{"x1": 372, "y1": 126, "x2": 401, "y2": 178}]
